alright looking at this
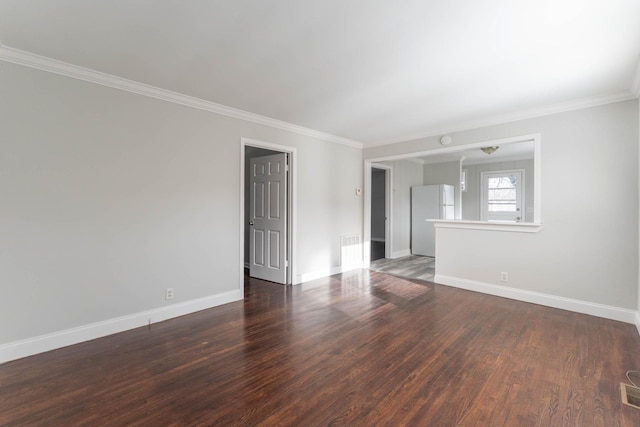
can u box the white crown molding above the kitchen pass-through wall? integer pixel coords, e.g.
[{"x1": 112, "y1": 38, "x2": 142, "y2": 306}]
[{"x1": 366, "y1": 89, "x2": 640, "y2": 148}]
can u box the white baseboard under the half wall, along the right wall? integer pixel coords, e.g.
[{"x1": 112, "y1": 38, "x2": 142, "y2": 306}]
[{"x1": 434, "y1": 274, "x2": 640, "y2": 324}]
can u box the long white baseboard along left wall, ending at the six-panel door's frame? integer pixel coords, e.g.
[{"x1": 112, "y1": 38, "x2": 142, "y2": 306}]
[{"x1": 0, "y1": 290, "x2": 244, "y2": 363}]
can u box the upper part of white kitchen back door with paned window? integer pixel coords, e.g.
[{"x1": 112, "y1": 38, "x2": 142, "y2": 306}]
[{"x1": 481, "y1": 169, "x2": 524, "y2": 222}]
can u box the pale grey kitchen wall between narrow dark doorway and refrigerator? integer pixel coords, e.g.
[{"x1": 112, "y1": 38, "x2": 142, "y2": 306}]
[{"x1": 382, "y1": 160, "x2": 423, "y2": 258}]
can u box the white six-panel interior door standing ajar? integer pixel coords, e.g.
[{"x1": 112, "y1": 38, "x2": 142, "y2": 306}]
[{"x1": 249, "y1": 153, "x2": 288, "y2": 284}]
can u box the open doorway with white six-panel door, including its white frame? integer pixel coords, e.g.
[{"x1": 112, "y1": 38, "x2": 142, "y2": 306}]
[{"x1": 240, "y1": 138, "x2": 295, "y2": 285}]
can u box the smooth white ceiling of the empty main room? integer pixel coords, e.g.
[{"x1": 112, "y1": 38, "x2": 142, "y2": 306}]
[{"x1": 0, "y1": 0, "x2": 640, "y2": 147}]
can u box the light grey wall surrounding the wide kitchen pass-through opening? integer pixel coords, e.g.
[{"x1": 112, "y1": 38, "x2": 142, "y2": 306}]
[{"x1": 365, "y1": 100, "x2": 638, "y2": 313}]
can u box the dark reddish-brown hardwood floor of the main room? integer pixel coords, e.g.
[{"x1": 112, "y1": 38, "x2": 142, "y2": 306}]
[{"x1": 0, "y1": 270, "x2": 640, "y2": 427}]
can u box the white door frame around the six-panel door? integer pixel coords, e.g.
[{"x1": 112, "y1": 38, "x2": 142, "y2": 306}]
[{"x1": 239, "y1": 137, "x2": 298, "y2": 289}]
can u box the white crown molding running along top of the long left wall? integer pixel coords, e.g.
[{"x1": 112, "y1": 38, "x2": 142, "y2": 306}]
[{"x1": 0, "y1": 43, "x2": 363, "y2": 148}]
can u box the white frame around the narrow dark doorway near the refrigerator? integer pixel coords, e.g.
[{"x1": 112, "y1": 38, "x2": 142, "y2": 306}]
[{"x1": 362, "y1": 160, "x2": 393, "y2": 268}]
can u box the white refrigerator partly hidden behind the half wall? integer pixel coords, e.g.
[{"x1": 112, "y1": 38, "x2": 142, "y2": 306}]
[{"x1": 411, "y1": 184, "x2": 454, "y2": 257}]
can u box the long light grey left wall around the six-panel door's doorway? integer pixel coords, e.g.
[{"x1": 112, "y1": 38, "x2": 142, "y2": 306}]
[{"x1": 0, "y1": 63, "x2": 363, "y2": 361}]
